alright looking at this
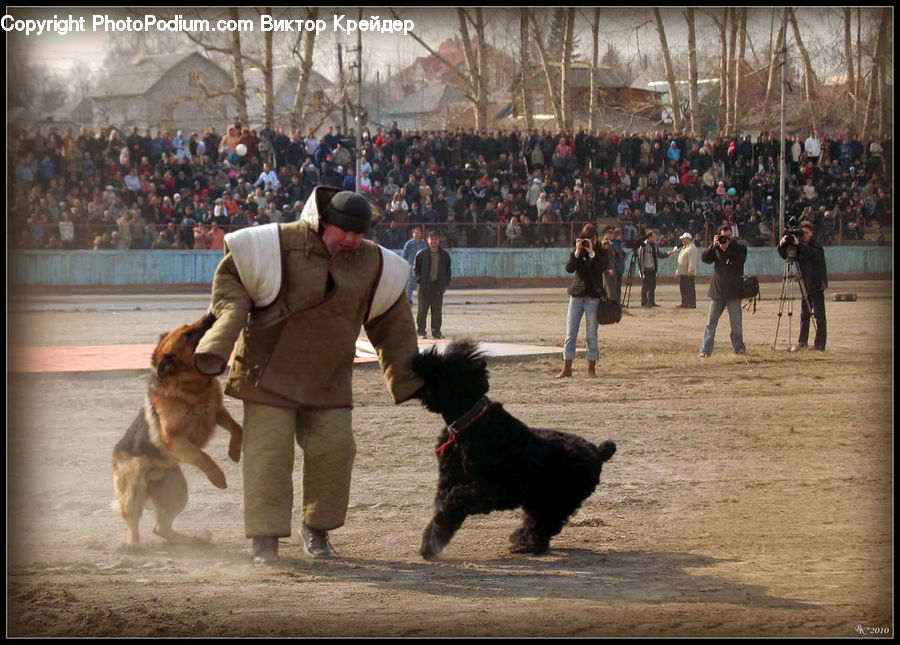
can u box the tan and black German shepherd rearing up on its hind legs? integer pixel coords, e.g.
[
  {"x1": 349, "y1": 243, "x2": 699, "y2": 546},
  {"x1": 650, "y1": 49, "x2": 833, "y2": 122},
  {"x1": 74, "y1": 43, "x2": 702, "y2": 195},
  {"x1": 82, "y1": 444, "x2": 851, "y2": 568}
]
[{"x1": 112, "y1": 314, "x2": 243, "y2": 547}]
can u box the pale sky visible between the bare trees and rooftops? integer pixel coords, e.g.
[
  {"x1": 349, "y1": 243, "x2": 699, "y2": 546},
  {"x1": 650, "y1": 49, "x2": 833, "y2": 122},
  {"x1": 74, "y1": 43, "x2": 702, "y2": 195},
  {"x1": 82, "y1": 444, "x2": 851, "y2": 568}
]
[{"x1": 7, "y1": 7, "x2": 880, "y2": 82}]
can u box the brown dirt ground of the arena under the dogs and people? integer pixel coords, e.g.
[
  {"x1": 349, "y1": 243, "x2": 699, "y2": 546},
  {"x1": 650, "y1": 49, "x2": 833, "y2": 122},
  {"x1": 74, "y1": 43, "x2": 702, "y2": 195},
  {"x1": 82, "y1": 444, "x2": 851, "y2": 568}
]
[{"x1": 7, "y1": 281, "x2": 894, "y2": 637}]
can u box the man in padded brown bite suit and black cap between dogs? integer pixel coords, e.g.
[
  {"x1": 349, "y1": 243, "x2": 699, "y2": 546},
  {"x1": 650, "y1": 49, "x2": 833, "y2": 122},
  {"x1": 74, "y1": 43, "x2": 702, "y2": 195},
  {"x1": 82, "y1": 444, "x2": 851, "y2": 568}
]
[{"x1": 194, "y1": 186, "x2": 423, "y2": 563}]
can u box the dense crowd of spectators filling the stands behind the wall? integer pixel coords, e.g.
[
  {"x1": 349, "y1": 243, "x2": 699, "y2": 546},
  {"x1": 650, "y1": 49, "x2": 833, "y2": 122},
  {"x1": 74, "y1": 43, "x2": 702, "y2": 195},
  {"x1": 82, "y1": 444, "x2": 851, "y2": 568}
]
[{"x1": 8, "y1": 118, "x2": 892, "y2": 249}]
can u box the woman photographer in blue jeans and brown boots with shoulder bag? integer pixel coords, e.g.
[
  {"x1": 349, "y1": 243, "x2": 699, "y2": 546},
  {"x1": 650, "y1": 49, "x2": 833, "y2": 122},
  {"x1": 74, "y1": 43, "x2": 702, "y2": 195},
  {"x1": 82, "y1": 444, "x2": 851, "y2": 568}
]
[{"x1": 555, "y1": 224, "x2": 609, "y2": 378}]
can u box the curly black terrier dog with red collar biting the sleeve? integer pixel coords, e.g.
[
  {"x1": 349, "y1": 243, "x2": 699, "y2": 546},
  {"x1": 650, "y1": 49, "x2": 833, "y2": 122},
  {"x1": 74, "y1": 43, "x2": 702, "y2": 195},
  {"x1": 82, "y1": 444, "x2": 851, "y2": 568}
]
[{"x1": 412, "y1": 341, "x2": 616, "y2": 559}]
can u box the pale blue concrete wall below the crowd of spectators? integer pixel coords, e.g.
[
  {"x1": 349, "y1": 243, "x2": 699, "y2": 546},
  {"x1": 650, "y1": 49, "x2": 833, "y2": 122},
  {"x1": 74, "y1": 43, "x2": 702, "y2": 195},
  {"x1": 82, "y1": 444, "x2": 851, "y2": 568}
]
[{"x1": 8, "y1": 246, "x2": 893, "y2": 286}]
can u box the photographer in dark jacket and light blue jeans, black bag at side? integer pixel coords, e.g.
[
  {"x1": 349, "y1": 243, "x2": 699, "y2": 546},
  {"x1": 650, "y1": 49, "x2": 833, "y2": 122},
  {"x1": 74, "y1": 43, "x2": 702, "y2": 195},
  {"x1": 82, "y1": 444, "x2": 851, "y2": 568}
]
[{"x1": 699, "y1": 225, "x2": 747, "y2": 358}]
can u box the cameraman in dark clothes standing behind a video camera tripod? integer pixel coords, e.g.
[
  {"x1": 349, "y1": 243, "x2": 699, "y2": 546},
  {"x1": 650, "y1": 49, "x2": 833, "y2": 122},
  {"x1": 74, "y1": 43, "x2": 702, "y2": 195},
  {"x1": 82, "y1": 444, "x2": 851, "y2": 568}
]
[{"x1": 778, "y1": 221, "x2": 828, "y2": 352}]
